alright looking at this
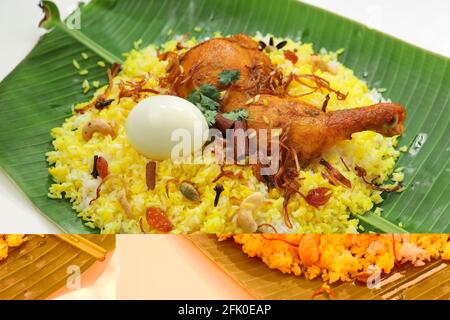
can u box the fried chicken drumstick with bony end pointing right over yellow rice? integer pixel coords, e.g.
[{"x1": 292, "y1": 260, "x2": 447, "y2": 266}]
[{"x1": 245, "y1": 95, "x2": 406, "y2": 161}]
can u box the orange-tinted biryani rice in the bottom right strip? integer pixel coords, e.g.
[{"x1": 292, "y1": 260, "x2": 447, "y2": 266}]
[{"x1": 219, "y1": 234, "x2": 450, "y2": 283}]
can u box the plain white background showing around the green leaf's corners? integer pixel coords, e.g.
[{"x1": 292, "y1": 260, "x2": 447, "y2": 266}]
[{"x1": 0, "y1": 0, "x2": 450, "y2": 233}]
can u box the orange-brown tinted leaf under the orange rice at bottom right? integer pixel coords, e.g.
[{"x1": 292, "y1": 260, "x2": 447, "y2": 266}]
[{"x1": 188, "y1": 233, "x2": 450, "y2": 300}]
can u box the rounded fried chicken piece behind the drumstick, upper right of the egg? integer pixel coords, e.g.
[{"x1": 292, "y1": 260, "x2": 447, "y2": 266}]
[{"x1": 174, "y1": 34, "x2": 275, "y2": 109}]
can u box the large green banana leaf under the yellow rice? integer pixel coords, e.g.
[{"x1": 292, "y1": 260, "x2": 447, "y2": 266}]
[{"x1": 0, "y1": 0, "x2": 450, "y2": 233}]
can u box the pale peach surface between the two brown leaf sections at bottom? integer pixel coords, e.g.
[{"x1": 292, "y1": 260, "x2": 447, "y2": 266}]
[{"x1": 116, "y1": 235, "x2": 252, "y2": 299}]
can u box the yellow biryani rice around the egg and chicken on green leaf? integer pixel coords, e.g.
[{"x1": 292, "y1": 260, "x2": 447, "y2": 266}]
[{"x1": 47, "y1": 34, "x2": 403, "y2": 233}]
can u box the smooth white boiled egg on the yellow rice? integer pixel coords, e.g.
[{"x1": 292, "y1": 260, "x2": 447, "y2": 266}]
[{"x1": 125, "y1": 95, "x2": 208, "y2": 160}]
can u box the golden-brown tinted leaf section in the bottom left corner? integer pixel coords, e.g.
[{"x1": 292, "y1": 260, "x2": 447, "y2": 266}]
[{"x1": 0, "y1": 235, "x2": 116, "y2": 300}]
